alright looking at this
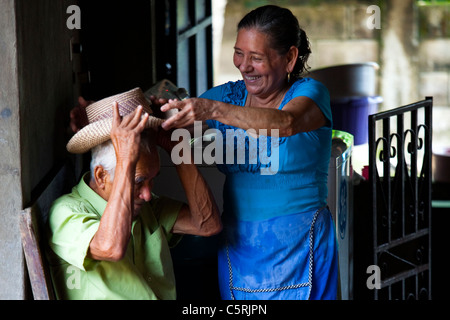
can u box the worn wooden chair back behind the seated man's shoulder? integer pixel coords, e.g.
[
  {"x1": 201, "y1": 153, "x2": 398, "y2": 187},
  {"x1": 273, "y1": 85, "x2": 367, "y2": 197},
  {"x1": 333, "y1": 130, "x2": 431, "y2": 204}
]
[{"x1": 19, "y1": 163, "x2": 75, "y2": 300}]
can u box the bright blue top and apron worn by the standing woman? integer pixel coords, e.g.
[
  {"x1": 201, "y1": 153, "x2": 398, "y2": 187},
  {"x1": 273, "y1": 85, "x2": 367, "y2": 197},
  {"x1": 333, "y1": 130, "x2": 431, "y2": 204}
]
[{"x1": 201, "y1": 78, "x2": 338, "y2": 300}]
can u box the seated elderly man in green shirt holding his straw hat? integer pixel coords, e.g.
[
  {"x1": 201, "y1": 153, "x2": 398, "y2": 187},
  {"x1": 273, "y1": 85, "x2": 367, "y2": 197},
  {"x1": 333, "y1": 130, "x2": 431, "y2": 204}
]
[{"x1": 47, "y1": 89, "x2": 222, "y2": 299}]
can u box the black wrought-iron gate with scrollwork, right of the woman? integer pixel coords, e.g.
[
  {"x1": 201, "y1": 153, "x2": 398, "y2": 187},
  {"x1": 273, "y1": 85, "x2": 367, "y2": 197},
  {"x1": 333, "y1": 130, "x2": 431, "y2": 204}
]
[{"x1": 369, "y1": 97, "x2": 433, "y2": 300}]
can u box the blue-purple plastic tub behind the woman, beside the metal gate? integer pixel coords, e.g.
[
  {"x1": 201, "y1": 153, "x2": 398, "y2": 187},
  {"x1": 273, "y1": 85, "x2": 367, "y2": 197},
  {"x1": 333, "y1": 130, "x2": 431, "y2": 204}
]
[{"x1": 331, "y1": 96, "x2": 383, "y2": 145}]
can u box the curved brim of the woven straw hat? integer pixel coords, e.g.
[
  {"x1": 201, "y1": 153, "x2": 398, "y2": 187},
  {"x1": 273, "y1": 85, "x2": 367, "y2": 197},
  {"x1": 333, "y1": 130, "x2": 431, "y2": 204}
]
[{"x1": 66, "y1": 116, "x2": 165, "y2": 154}]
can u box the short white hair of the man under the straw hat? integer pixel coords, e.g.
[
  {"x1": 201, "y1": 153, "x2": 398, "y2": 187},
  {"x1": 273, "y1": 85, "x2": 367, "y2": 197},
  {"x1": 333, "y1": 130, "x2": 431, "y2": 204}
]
[{"x1": 90, "y1": 130, "x2": 157, "y2": 181}]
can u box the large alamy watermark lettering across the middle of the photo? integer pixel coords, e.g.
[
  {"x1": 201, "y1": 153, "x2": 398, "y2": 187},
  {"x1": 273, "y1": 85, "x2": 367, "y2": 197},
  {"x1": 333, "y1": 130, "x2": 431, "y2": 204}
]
[{"x1": 171, "y1": 121, "x2": 280, "y2": 175}]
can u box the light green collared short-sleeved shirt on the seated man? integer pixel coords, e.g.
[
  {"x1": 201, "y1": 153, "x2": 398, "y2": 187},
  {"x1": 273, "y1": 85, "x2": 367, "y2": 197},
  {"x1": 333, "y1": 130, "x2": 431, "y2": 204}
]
[{"x1": 47, "y1": 174, "x2": 183, "y2": 300}]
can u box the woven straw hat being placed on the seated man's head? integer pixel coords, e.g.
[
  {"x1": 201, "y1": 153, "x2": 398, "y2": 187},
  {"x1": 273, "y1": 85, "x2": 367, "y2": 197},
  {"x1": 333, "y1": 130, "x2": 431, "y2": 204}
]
[{"x1": 67, "y1": 88, "x2": 164, "y2": 153}]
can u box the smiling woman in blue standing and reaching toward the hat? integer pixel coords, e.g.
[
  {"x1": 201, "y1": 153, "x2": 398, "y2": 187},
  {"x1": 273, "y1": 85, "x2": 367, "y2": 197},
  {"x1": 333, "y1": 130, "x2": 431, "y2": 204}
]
[{"x1": 161, "y1": 6, "x2": 337, "y2": 299}]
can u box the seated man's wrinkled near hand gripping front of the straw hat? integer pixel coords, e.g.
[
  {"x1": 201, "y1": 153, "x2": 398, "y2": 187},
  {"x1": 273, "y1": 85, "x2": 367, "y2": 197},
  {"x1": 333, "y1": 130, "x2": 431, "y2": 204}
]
[{"x1": 111, "y1": 102, "x2": 149, "y2": 164}]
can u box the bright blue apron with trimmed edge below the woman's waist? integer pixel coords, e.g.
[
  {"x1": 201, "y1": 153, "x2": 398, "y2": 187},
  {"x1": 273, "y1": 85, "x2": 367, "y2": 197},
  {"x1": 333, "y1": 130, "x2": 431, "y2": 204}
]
[{"x1": 219, "y1": 208, "x2": 338, "y2": 300}]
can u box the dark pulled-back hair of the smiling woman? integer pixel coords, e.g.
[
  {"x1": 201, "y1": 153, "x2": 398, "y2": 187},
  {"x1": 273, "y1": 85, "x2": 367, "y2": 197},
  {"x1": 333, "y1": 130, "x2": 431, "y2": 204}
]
[{"x1": 238, "y1": 5, "x2": 311, "y2": 78}]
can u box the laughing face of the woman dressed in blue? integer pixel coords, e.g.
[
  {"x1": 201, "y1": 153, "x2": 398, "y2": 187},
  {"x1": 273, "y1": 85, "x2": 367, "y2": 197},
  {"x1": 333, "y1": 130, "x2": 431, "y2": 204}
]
[{"x1": 233, "y1": 29, "x2": 288, "y2": 98}]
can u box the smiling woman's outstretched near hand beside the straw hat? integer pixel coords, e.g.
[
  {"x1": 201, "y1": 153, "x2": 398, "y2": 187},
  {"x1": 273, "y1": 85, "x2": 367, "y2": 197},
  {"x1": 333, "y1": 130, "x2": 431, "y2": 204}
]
[{"x1": 161, "y1": 98, "x2": 213, "y2": 130}]
